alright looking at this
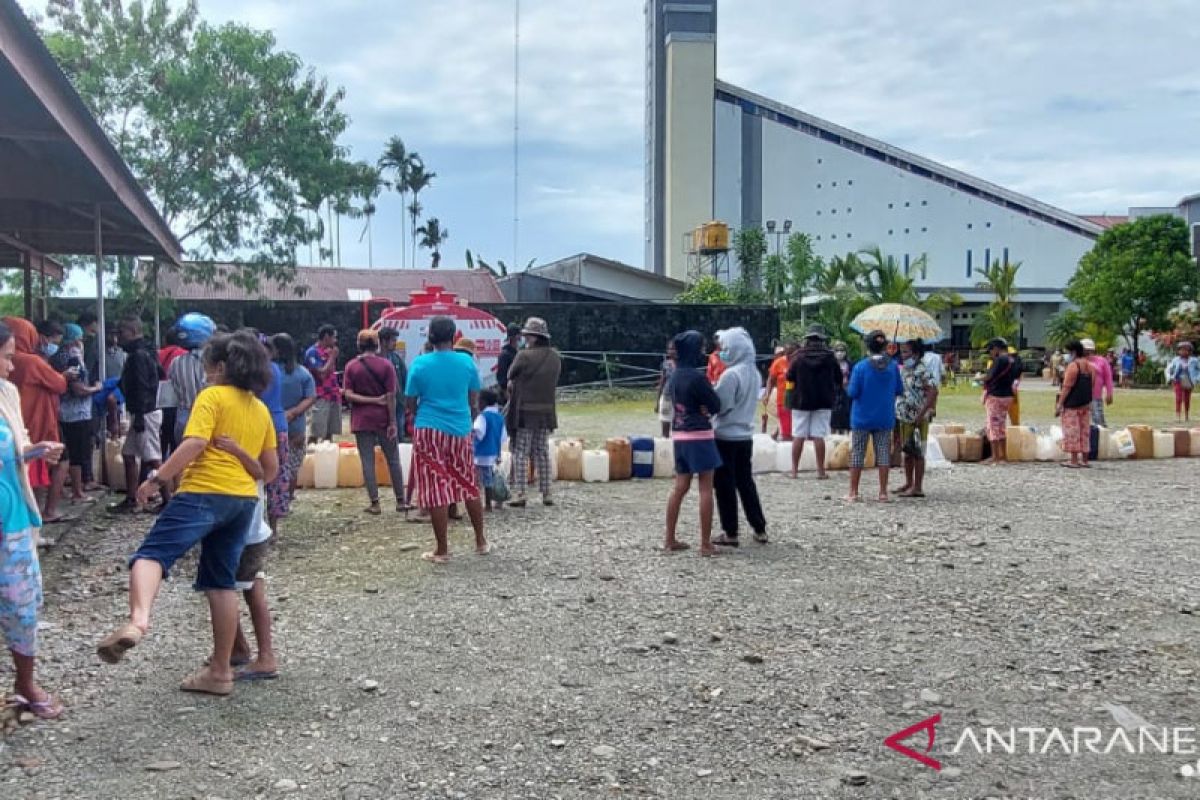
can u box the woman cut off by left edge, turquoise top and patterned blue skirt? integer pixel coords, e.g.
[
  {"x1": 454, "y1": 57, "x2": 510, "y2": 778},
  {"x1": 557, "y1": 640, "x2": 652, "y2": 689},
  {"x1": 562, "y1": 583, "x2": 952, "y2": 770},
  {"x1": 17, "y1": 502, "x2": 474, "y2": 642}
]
[{"x1": 0, "y1": 320, "x2": 62, "y2": 720}]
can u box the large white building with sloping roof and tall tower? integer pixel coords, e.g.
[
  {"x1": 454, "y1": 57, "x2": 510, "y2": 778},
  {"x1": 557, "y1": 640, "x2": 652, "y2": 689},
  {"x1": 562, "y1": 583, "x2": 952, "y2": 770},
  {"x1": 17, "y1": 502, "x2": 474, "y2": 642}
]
[{"x1": 646, "y1": 0, "x2": 1104, "y2": 347}]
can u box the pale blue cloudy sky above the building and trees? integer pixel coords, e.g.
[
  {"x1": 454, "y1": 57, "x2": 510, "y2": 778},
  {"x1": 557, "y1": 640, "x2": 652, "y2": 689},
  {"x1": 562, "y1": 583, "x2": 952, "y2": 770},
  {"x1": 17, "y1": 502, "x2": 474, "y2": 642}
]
[{"x1": 26, "y1": 0, "x2": 1200, "y2": 277}]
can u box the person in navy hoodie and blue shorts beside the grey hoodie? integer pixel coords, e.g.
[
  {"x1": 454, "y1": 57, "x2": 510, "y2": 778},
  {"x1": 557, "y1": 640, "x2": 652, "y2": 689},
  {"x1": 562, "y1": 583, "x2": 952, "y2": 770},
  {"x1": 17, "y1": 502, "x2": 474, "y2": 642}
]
[{"x1": 662, "y1": 331, "x2": 721, "y2": 555}]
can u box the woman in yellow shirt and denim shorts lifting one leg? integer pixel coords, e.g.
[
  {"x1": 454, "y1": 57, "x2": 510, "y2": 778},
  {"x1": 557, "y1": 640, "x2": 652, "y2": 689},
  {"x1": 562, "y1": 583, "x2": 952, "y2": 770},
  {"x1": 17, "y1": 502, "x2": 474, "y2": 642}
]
[{"x1": 96, "y1": 331, "x2": 278, "y2": 694}]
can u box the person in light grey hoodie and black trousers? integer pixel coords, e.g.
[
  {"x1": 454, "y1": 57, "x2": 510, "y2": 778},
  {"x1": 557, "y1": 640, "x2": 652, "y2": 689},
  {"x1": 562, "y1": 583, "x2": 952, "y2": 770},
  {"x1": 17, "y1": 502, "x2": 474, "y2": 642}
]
[{"x1": 713, "y1": 327, "x2": 768, "y2": 547}]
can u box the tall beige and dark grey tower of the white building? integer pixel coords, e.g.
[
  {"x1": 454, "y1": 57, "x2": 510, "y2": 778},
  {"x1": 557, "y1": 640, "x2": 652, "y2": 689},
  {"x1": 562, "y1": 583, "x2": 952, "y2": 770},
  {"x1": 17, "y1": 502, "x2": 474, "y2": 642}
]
[{"x1": 646, "y1": 0, "x2": 716, "y2": 279}]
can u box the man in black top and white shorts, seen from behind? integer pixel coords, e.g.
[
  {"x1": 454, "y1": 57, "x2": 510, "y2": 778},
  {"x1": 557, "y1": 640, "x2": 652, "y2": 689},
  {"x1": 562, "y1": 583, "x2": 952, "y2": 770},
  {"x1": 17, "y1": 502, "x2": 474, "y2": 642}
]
[{"x1": 787, "y1": 325, "x2": 841, "y2": 480}]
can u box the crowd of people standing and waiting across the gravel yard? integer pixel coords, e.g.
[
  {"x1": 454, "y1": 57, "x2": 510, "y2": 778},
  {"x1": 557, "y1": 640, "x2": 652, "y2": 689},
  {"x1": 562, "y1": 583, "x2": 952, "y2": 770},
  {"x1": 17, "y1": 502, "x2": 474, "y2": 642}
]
[{"x1": 0, "y1": 304, "x2": 1200, "y2": 705}]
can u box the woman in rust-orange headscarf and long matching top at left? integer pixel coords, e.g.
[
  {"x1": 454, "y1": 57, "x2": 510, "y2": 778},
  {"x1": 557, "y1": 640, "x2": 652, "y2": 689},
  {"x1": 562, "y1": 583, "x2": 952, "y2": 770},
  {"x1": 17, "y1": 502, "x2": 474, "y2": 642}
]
[{"x1": 4, "y1": 317, "x2": 71, "y2": 524}]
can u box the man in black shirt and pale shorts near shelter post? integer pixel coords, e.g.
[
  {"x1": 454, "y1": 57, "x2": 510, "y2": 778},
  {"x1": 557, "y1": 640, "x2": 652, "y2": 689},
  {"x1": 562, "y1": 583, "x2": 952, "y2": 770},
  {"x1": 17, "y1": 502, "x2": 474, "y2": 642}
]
[{"x1": 114, "y1": 318, "x2": 170, "y2": 511}]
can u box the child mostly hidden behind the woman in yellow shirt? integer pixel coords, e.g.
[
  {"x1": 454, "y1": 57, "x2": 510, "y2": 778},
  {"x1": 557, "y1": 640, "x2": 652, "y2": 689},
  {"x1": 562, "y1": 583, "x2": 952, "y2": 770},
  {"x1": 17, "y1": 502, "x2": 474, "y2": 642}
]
[{"x1": 214, "y1": 437, "x2": 277, "y2": 681}]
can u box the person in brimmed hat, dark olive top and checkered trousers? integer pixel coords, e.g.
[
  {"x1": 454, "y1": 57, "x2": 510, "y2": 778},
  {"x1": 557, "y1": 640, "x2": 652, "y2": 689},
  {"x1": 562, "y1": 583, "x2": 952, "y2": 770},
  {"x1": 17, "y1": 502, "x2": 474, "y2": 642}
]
[{"x1": 505, "y1": 317, "x2": 563, "y2": 509}]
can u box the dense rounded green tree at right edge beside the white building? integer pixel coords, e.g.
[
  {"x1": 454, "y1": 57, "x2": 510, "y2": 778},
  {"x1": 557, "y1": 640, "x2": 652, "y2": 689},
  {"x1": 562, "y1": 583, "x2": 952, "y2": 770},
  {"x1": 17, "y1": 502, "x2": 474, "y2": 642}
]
[{"x1": 1066, "y1": 215, "x2": 1196, "y2": 356}]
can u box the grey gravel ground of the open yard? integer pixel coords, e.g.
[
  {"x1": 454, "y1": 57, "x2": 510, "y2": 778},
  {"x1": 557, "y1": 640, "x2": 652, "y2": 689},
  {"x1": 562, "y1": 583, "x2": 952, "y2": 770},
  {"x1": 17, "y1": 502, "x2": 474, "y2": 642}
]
[{"x1": 0, "y1": 461, "x2": 1200, "y2": 800}]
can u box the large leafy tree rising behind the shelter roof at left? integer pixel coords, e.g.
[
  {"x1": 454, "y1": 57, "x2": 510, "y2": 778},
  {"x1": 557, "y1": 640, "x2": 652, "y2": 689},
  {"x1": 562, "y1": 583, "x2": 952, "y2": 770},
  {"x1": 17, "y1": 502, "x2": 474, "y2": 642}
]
[{"x1": 43, "y1": 0, "x2": 347, "y2": 291}]
